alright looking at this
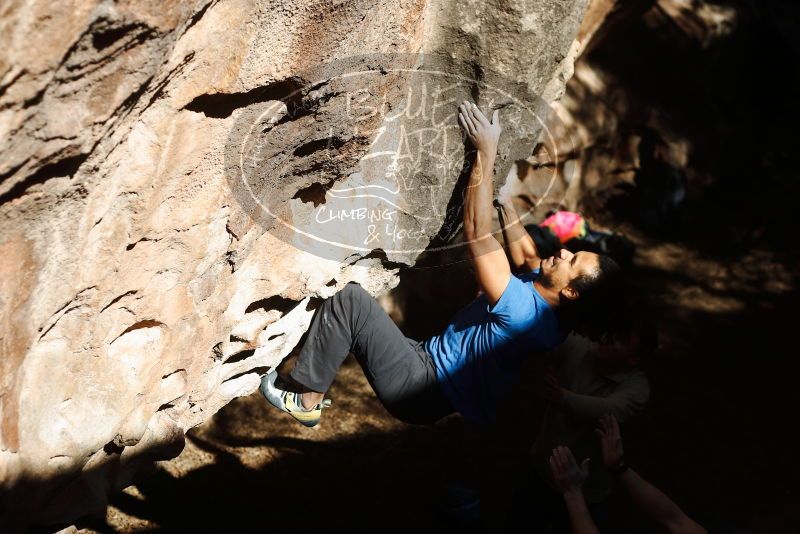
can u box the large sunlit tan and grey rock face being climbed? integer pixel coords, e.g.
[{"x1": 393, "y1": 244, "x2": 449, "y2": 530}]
[{"x1": 0, "y1": 0, "x2": 586, "y2": 529}]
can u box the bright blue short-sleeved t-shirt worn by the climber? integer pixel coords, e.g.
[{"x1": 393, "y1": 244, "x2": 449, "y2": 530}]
[{"x1": 424, "y1": 270, "x2": 564, "y2": 423}]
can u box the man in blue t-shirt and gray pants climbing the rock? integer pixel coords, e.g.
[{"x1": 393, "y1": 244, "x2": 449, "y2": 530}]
[{"x1": 261, "y1": 102, "x2": 617, "y2": 426}]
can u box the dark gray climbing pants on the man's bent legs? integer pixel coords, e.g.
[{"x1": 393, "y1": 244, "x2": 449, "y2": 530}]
[{"x1": 290, "y1": 282, "x2": 453, "y2": 424}]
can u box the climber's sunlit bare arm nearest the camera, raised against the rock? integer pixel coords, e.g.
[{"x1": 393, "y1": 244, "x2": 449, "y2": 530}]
[{"x1": 458, "y1": 102, "x2": 511, "y2": 305}]
